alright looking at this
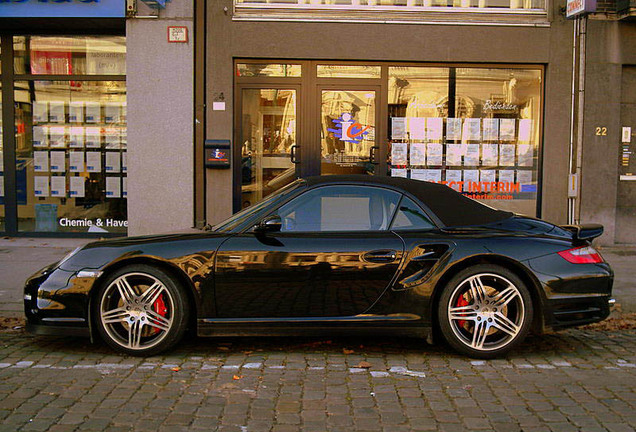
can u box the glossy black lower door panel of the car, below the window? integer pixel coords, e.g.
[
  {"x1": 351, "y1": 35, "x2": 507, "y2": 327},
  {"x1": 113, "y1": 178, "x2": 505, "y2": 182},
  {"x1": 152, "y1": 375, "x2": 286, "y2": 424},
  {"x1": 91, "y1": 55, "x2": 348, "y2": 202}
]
[{"x1": 215, "y1": 231, "x2": 403, "y2": 318}]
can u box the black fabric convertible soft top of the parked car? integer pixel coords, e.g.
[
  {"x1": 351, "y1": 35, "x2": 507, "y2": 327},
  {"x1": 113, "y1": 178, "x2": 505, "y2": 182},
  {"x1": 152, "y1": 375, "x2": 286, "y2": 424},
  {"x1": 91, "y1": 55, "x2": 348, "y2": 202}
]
[{"x1": 305, "y1": 175, "x2": 513, "y2": 227}]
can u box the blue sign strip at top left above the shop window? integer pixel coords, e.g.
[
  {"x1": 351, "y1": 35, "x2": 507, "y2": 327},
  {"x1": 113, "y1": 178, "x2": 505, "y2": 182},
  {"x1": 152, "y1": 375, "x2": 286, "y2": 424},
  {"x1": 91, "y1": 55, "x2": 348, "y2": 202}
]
[{"x1": 0, "y1": 0, "x2": 126, "y2": 18}]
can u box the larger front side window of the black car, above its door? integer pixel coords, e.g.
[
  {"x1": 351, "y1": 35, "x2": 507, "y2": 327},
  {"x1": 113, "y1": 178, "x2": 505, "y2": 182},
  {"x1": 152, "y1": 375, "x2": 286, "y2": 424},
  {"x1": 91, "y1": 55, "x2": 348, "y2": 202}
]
[{"x1": 278, "y1": 186, "x2": 400, "y2": 232}]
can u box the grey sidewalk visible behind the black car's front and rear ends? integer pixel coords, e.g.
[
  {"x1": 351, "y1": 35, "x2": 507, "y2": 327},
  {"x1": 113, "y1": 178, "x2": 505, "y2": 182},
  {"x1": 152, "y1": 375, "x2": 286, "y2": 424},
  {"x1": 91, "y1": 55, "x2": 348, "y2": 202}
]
[{"x1": 0, "y1": 238, "x2": 636, "y2": 316}]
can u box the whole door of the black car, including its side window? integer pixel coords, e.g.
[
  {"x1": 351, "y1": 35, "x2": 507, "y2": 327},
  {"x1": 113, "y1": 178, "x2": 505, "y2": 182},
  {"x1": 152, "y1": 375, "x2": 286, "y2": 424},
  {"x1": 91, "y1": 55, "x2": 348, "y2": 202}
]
[{"x1": 215, "y1": 185, "x2": 404, "y2": 319}]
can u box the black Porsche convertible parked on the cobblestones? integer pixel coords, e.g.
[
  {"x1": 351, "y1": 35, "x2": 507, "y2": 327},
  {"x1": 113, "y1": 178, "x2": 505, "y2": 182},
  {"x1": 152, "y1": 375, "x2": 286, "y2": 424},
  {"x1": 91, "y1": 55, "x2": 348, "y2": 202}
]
[{"x1": 24, "y1": 176, "x2": 613, "y2": 358}]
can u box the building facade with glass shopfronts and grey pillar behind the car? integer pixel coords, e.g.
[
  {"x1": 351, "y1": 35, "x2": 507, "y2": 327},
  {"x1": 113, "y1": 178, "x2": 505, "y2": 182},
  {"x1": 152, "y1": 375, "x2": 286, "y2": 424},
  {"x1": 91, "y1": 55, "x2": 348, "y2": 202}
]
[{"x1": 0, "y1": 0, "x2": 636, "y2": 244}]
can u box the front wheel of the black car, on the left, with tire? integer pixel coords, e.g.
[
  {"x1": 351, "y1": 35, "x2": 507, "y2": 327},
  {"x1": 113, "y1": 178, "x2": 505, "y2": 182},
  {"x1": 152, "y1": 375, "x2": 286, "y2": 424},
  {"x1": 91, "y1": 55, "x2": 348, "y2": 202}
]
[{"x1": 92, "y1": 264, "x2": 190, "y2": 356}]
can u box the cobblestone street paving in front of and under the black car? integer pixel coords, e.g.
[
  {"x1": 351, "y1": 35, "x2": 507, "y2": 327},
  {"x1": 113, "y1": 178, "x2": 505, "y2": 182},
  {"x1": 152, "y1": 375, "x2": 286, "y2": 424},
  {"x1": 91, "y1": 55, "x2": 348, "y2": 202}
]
[{"x1": 0, "y1": 330, "x2": 636, "y2": 432}]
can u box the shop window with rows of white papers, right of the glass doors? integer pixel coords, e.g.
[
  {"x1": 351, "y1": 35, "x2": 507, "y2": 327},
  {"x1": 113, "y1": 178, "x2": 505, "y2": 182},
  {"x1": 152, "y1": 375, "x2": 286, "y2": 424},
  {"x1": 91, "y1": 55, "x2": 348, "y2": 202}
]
[{"x1": 388, "y1": 67, "x2": 542, "y2": 215}]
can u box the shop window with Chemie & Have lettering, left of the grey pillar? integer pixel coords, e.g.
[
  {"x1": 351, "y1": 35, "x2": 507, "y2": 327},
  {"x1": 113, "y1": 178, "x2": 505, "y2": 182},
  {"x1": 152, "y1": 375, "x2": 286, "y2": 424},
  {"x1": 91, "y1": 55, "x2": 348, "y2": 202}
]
[{"x1": 15, "y1": 80, "x2": 127, "y2": 234}]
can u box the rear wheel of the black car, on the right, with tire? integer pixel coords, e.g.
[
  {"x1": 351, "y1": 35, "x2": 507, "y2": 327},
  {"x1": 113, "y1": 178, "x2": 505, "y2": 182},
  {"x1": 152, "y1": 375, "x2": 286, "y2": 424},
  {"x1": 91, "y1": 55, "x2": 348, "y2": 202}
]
[{"x1": 438, "y1": 265, "x2": 533, "y2": 358}]
